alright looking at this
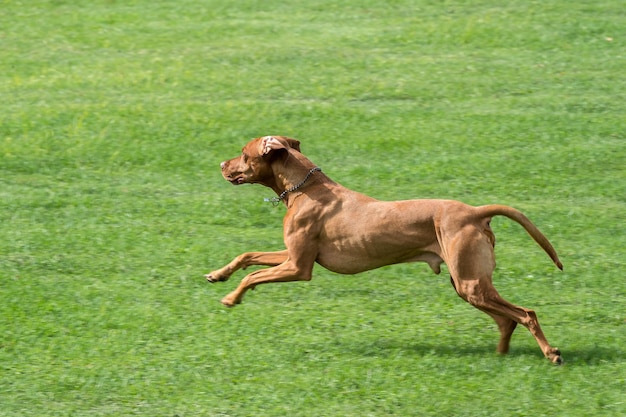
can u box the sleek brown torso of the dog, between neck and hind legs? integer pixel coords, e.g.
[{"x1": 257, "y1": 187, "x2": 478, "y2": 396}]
[{"x1": 284, "y1": 179, "x2": 491, "y2": 274}]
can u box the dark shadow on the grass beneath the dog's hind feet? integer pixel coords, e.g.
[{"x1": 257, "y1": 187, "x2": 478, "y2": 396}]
[{"x1": 350, "y1": 339, "x2": 626, "y2": 366}]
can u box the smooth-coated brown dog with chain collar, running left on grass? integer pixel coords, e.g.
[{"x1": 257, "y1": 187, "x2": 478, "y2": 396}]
[{"x1": 205, "y1": 136, "x2": 563, "y2": 364}]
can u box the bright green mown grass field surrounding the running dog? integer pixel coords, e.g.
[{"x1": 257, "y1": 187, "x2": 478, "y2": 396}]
[{"x1": 0, "y1": 0, "x2": 626, "y2": 417}]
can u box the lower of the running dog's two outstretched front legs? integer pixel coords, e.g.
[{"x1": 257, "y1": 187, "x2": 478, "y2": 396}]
[{"x1": 222, "y1": 260, "x2": 313, "y2": 307}]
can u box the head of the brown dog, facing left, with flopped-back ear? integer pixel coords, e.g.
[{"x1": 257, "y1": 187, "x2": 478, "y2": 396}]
[{"x1": 220, "y1": 136, "x2": 300, "y2": 185}]
